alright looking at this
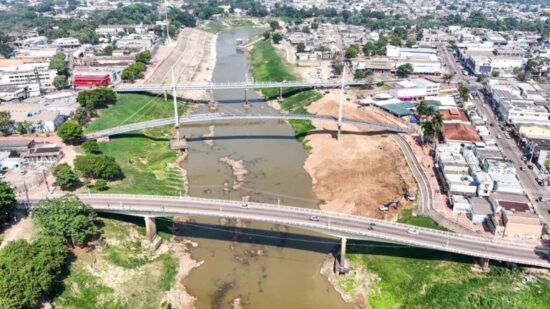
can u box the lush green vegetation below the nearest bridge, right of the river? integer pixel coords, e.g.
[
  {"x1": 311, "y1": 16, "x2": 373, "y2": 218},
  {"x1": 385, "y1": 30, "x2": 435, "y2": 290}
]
[{"x1": 347, "y1": 242, "x2": 550, "y2": 309}]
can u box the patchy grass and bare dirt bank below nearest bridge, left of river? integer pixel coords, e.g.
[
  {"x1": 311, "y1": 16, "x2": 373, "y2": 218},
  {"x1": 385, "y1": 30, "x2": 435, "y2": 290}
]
[{"x1": 54, "y1": 219, "x2": 179, "y2": 309}]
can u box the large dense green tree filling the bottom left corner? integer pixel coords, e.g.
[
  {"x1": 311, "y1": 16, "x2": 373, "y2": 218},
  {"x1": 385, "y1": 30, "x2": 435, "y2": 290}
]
[{"x1": 0, "y1": 235, "x2": 69, "y2": 308}]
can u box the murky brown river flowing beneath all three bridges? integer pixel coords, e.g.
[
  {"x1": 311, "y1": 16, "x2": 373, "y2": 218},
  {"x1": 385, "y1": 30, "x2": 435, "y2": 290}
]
[{"x1": 182, "y1": 29, "x2": 350, "y2": 308}]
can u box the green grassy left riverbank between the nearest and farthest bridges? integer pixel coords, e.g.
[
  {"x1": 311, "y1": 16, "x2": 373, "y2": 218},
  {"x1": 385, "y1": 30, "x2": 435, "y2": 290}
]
[{"x1": 86, "y1": 94, "x2": 185, "y2": 195}]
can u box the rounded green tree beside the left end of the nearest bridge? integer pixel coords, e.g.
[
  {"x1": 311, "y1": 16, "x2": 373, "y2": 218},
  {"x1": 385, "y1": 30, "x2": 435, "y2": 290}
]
[{"x1": 31, "y1": 195, "x2": 100, "y2": 246}]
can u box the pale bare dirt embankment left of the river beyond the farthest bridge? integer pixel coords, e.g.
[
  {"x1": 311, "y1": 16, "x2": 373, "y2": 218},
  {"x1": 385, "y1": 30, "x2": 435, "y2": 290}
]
[{"x1": 143, "y1": 28, "x2": 217, "y2": 100}]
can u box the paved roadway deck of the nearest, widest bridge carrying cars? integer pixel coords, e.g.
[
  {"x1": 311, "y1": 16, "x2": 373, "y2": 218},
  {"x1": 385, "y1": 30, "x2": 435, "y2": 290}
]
[{"x1": 24, "y1": 194, "x2": 550, "y2": 268}]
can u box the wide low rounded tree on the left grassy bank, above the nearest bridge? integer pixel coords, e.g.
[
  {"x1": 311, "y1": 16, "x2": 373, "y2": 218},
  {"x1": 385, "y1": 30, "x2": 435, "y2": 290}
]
[{"x1": 74, "y1": 155, "x2": 124, "y2": 180}]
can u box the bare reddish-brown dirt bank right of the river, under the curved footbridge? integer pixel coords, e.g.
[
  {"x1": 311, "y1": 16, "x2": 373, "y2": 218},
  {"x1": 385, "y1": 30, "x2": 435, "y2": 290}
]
[{"x1": 304, "y1": 91, "x2": 416, "y2": 220}]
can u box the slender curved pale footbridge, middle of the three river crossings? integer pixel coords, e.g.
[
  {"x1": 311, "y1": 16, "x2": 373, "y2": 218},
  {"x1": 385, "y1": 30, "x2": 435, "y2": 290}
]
[{"x1": 85, "y1": 113, "x2": 409, "y2": 139}]
